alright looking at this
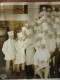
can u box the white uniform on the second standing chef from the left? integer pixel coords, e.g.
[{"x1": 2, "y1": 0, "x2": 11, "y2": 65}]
[{"x1": 15, "y1": 40, "x2": 25, "y2": 64}]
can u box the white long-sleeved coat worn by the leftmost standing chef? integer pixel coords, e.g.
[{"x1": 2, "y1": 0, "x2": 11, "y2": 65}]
[{"x1": 2, "y1": 38, "x2": 16, "y2": 60}]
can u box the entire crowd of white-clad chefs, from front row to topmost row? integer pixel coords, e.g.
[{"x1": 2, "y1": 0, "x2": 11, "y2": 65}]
[{"x1": 2, "y1": 7, "x2": 60, "y2": 78}]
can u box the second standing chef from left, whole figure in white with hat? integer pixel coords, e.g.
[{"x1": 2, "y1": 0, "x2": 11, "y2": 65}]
[{"x1": 15, "y1": 32, "x2": 25, "y2": 72}]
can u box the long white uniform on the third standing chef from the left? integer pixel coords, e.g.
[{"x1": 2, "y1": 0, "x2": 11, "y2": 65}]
[{"x1": 25, "y1": 37, "x2": 35, "y2": 65}]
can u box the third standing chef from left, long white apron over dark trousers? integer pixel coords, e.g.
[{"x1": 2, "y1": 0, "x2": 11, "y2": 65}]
[{"x1": 25, "y1": 28, "x2": 35, "y2": 77}]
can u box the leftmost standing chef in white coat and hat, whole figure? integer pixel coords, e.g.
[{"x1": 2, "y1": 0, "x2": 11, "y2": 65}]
[{"x1": 2, "y1": 31, "x2": 16, "y2": 72}]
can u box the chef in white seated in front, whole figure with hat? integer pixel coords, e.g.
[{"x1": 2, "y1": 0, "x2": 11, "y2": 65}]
[{"x1": 34, "y1": 39, "x2": 50, "y2": 78}]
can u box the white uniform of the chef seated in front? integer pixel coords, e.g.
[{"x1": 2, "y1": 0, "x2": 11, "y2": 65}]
[{"x1": 34, "y1": 39, "x2": 50, "y2": 69}]
